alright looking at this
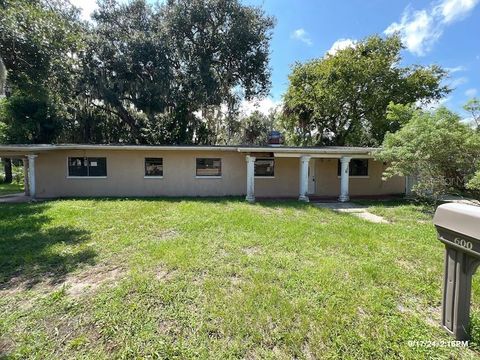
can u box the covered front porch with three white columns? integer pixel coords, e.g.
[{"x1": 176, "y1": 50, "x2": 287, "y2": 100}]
[{"x1": 239, "y1": 148, "x2": 373, "y2": 202}]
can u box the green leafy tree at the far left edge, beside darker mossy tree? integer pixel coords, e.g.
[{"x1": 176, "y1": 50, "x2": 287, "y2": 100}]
[{"x1": 0, "y1": 0, "x2": 82, "y2": 143}]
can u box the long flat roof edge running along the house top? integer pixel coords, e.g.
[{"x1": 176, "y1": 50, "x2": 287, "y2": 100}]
[{"x1": 0, "y1": 144, "x2": 379, "y2": 155}]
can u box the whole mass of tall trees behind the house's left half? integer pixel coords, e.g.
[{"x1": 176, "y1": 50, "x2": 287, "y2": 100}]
[{"x1": 0, "y1": 0, "x2": 274, "y2": 144}]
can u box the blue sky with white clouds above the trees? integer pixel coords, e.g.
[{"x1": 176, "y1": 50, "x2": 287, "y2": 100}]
[{"x1": 72, "y1": 0, "x2": 480, "y2": 117}]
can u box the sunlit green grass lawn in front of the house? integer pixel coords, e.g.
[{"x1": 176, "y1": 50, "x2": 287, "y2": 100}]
[{"x1": 0, "y1": 199, "x2": 480, "y2": 359}]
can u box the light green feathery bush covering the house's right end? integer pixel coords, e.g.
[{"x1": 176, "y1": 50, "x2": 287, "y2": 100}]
[{"x1": 376, "y1": 104, "x2": 480, "y2": 196}]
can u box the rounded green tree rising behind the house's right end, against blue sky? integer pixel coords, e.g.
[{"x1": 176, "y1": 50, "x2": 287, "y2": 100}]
[{"x1": 283, "y1": 36, "x2": 449, "y2": 146}]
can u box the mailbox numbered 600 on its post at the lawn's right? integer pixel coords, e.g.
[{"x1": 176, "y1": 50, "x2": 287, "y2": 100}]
[{"x1": 433, "y1": 204, "x2": 480, "y2": 340}]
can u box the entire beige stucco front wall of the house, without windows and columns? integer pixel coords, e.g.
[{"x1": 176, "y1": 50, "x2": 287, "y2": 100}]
[{"x1": 36, "y1": 150, "x2": 405, "y2": 198}]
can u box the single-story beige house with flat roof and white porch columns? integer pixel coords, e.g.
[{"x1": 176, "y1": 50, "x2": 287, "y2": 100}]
[{"x1": 0, "y1": 144, "x2": 406, "y2": 201}]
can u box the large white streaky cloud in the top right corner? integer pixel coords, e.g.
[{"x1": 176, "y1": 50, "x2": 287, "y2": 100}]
[{"x1": 384, "y1": 0, "x2": 480, "y2": 56}]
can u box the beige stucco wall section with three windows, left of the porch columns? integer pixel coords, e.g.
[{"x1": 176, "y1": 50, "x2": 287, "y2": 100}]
[{"x1": 36, "y1": 150, "x2": 246, "y2": 197}]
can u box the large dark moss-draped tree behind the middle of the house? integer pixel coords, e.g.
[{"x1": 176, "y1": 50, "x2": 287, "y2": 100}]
[{"x1": 84, "y1": 0, "x2": 273, "y2": 143}]
